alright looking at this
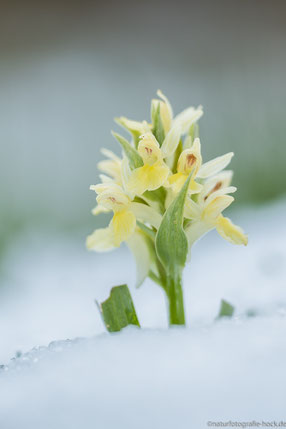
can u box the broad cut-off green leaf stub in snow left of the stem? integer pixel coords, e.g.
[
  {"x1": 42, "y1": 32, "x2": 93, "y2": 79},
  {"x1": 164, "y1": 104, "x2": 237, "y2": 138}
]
[{"x1": 96, "y1": 285, "x2": 140, "y2": 332}]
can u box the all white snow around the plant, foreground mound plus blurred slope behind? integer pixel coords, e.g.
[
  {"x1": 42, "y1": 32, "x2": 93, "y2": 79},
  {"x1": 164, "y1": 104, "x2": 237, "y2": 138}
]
[{"x1": 0, "y1": 200, "x2": 286, "y2": 429}]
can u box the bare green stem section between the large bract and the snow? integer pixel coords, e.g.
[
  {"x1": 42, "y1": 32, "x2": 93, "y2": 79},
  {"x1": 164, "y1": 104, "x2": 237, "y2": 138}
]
[{"x1": 167, "y1": 276, "x2": 185, "y2": 325}]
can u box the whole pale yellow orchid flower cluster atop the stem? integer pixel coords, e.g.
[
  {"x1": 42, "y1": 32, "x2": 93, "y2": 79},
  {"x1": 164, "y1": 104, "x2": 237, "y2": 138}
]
[{"x1": 87, "y1": 91, "x2": 247, "y2": 294}]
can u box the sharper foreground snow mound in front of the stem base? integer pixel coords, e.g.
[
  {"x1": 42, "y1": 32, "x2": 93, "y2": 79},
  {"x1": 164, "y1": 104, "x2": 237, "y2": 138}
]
[{"x1": 0, "y1": 314, "x2": 286, "y2": 429}]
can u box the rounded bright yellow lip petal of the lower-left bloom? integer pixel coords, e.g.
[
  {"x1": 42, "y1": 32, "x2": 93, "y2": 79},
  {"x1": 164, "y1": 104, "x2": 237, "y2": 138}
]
[{"x1": 110, "y1": 210, "x2": 136, "y2": 246}]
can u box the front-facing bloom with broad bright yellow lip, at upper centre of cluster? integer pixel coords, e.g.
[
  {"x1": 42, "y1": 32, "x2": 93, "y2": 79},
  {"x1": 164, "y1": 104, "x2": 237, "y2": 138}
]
[{"x1": 127, "y1": 132, "x2": 170, "y2": 195}]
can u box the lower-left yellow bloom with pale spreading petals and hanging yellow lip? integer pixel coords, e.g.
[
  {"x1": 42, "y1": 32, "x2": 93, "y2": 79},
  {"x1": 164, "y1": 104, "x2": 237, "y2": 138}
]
[{"x1": 86, "y1": 183, "x2": 161, "y2": 251}]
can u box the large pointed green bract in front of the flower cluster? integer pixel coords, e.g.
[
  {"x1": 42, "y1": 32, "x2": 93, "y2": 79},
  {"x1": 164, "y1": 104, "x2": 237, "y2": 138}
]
[{"x1": 156, "y1": 173, "x2": 192, "y2": 277}]
